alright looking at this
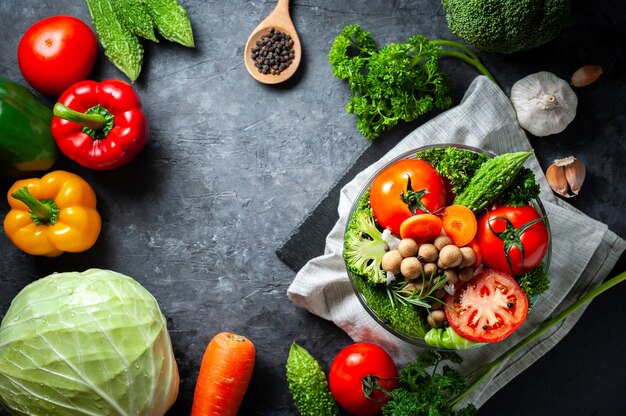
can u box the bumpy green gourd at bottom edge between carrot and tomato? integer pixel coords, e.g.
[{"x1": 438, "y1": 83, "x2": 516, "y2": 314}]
[{"x1": 287, "y1": 342, "x2": 339, "y2": 416}]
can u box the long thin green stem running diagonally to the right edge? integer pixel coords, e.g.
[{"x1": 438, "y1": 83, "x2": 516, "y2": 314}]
[{"x1": 452, "y1": 272, "x2": 626, "y2": 406}]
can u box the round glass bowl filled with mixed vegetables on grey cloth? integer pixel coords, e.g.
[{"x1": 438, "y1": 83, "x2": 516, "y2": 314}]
[{"x1": 343, "y1": 144, "x2": 551, "y2": 350}]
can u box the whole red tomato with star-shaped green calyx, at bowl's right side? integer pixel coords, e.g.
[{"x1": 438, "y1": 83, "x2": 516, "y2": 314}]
[{"x1": 477, "y1": 205, "x2": 550, "y2": 276}]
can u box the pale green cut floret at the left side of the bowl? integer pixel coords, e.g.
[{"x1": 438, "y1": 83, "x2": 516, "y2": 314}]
[{"x1": 343, "y1": 192, "x2": 388, "y2": 284}]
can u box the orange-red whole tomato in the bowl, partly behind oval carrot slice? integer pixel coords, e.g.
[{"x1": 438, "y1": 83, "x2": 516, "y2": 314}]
[{"x1": 370, "y1": 159, "x2": 446, "y2": 235}]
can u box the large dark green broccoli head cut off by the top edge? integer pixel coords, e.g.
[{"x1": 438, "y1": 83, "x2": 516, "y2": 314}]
[{"x1": 442, "y1": 0, "x2": 570, "y2": 54}]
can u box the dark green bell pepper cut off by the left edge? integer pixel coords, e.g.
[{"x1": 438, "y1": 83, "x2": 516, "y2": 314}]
[{"x1": 0, "y1": 77, "x2": 59, "y2": 177}]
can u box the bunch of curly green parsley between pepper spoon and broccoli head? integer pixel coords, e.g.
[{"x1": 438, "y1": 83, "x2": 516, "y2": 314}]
[{"x1": 328, "y1": 25, "x2": 493, "y2": 140}]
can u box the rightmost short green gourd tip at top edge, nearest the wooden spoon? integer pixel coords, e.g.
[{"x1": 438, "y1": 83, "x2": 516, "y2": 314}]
[{"x1": 142, "y1": 0, "x2": 194, "y2": 48}]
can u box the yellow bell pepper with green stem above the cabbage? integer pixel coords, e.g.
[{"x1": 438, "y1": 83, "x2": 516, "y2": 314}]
[{"x1": 4, "y1": 170, "x2": 102, "y2": 257}]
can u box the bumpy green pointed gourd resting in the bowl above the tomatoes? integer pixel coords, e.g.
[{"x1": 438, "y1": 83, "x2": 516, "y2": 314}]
[{"x1": 454, "y1": 152, "x2": 533, "y2": 212}]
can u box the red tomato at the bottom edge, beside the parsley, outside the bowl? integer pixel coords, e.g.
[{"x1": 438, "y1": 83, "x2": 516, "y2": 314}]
[{"x1": 328, "y1": 342, "x2": 398, "y2": 416}]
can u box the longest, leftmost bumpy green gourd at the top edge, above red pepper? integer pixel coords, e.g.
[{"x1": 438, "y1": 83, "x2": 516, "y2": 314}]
[{"x1": 85, "y1": 0, "x2": 143, "y2": 82}]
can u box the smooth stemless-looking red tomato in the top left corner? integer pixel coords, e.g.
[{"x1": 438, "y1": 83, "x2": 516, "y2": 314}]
[{"x1": 17, "y1": 16, "x2": 98, "y2": 97}]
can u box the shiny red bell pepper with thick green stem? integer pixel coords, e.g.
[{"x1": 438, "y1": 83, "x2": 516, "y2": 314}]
[{"x1": 51, "y1": 80, "x2": 148, "y2": 170}]
